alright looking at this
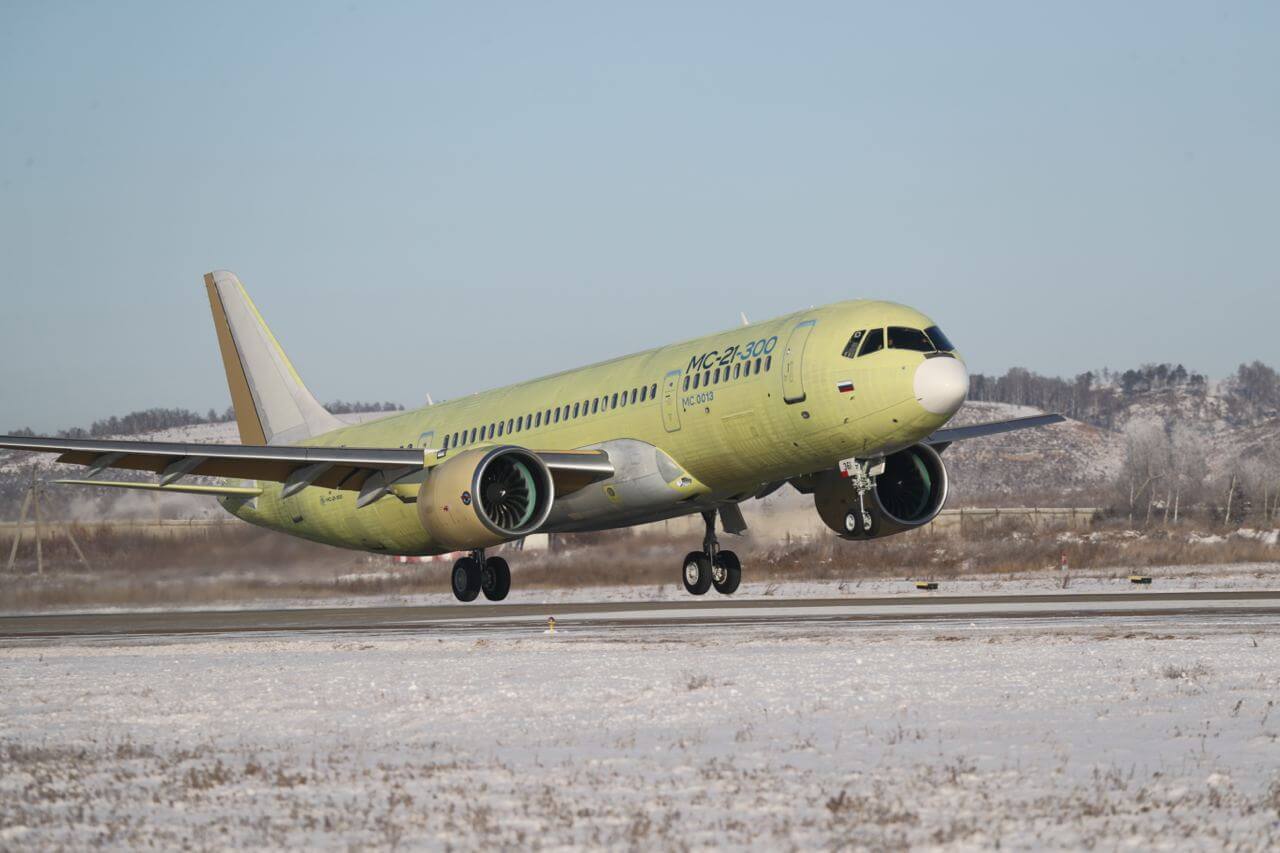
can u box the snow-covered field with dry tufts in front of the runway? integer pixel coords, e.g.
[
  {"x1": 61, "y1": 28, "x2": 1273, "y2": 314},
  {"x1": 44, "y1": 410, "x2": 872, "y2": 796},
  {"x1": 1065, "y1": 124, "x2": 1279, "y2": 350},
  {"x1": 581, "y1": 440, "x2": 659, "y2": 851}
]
[{"x1": 0, "y1": 616, "x2": 1280, "y2": 850}]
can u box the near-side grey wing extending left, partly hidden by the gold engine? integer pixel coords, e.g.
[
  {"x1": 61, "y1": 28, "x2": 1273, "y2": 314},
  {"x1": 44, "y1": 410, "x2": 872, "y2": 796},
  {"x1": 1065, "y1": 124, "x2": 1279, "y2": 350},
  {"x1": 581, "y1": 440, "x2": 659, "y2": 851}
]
[{"x1": 0, "y1": 435, "x2": 613, "y2": 506}]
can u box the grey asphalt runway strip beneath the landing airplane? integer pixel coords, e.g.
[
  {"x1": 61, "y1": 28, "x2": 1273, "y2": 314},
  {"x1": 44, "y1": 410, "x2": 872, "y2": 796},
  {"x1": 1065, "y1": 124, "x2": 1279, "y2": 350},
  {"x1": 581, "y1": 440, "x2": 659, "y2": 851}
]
[{"x1": 0, "y1": 590, "x2": 1280, "y2": 639}]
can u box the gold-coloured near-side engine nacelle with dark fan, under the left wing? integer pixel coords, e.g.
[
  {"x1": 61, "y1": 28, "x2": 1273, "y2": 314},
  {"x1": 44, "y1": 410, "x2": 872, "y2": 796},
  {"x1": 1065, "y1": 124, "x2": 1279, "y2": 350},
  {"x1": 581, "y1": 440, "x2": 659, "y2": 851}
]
[{"x1": 417, "y1": 447, "x2": 556, "y2": 551}]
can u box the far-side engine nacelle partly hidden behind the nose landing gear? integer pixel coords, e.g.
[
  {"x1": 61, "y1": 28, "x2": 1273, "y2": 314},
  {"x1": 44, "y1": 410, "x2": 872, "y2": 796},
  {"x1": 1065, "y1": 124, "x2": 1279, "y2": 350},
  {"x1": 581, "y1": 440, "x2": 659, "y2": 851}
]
[{"x1": 813, "y1": 444, "x2": 947, "y2": 539}]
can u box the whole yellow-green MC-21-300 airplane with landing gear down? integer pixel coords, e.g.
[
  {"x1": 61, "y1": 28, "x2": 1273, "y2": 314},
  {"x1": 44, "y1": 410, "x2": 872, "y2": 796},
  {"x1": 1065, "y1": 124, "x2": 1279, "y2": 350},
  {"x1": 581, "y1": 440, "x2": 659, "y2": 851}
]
[{"x1": 0, "y1": 270, "x2": 1064, "y2": 602}]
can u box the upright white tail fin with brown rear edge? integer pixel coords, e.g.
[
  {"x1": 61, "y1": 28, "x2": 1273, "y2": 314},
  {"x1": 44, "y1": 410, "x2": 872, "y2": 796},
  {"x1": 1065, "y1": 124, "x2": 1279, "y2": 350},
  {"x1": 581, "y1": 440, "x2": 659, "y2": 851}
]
[{"x1": 205, "y1": 270, "x2": 343, "y2": 444}]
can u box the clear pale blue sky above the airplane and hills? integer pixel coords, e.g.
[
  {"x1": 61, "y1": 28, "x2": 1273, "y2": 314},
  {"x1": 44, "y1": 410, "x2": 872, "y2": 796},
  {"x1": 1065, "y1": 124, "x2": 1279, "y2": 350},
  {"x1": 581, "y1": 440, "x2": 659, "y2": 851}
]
[{"x1": 0, "y1": 0, "x2": 1280, "y2": 430}]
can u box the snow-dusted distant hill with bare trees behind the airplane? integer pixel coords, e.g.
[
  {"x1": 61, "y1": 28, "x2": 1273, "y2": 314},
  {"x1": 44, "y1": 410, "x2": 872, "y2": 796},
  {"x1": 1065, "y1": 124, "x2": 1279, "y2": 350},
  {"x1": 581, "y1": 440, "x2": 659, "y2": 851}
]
[{"x1": 0, "y1": 362, "x2": 1280, "y2": 523}]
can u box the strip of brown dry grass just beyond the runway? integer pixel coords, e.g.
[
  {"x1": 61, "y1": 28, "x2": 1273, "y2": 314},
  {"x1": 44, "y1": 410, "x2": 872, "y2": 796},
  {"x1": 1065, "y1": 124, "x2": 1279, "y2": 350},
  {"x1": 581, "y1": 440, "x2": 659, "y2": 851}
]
[{"x1": 0, "y1": 519, "x2": 1280, "y2": 610}]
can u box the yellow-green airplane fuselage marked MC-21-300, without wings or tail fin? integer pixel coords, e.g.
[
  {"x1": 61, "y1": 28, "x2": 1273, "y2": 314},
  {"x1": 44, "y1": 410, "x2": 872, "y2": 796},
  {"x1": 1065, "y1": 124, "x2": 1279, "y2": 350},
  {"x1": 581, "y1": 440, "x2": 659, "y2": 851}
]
[{"x1": 221, "y1": 301, "x2": 964, "y2": 555}]
